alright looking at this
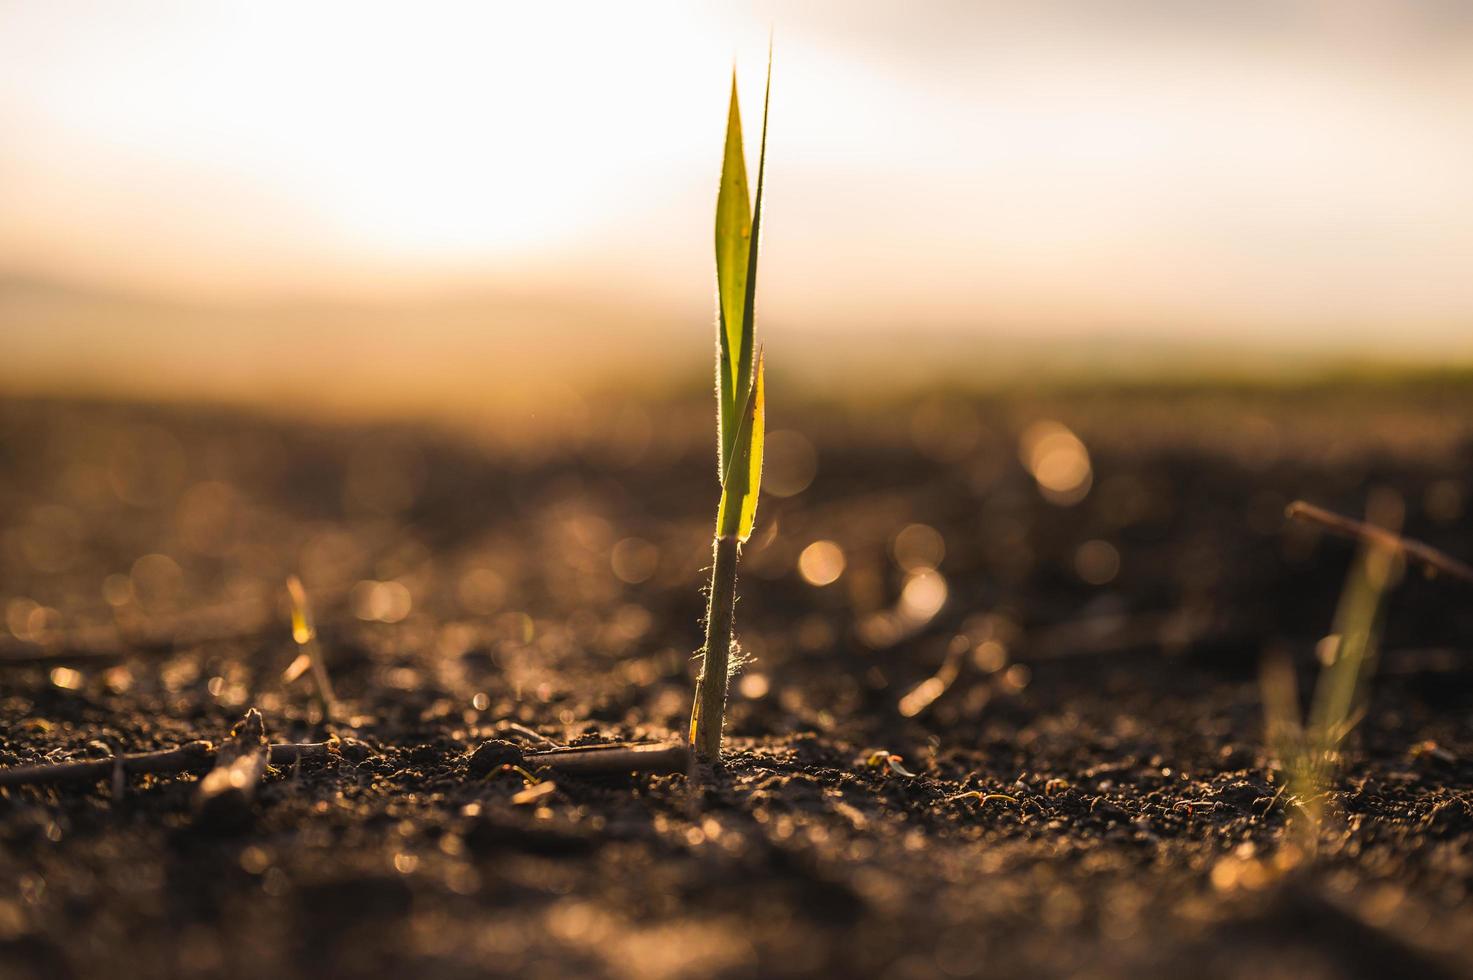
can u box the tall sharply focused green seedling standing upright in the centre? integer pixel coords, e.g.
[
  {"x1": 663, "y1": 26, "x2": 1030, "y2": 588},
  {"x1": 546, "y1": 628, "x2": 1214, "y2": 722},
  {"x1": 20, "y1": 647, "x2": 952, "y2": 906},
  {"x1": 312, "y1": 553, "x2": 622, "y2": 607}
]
[{"x1": 689, "y1": 61, "x2": 772, "y2": 762}]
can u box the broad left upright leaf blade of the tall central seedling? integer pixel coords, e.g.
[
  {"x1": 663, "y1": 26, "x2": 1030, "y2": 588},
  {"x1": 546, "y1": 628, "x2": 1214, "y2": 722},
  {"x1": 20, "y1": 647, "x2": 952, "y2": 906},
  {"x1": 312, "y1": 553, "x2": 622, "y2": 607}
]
[{"x1": 716, "y1": 71, "x2": 754, "y2": 476}]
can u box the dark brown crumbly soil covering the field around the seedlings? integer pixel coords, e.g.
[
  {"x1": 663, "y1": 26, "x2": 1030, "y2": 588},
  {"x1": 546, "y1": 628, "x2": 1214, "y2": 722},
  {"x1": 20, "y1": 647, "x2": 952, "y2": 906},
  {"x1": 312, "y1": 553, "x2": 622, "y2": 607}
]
[{"x1": 0, "y1": 379, "x2": 1473, "y2": 979}]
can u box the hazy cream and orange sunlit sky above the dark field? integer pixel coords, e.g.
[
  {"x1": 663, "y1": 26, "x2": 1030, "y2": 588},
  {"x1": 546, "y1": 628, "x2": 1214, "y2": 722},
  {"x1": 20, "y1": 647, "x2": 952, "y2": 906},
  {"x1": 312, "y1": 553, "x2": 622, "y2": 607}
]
[{"x1": 0, "y1": 0, "x2": 1473, "y2": 403}]
